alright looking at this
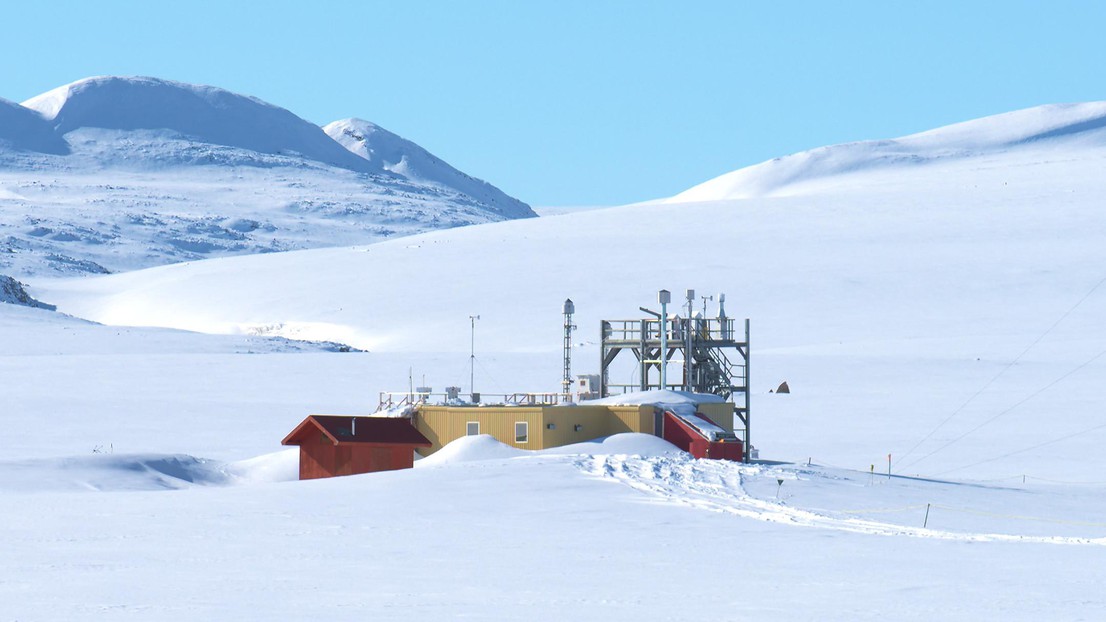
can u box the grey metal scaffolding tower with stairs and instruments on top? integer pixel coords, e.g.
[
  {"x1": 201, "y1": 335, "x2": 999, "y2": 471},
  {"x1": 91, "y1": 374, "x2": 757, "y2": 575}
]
[{"x1": 599, "y1": 290, "x2": 752, "y2": 459}]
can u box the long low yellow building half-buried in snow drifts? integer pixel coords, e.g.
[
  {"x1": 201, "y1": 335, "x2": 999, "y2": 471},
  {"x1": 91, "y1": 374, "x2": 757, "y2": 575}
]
[{"x1": 411, "y1": 402, "x2": 733, "y2": 456}]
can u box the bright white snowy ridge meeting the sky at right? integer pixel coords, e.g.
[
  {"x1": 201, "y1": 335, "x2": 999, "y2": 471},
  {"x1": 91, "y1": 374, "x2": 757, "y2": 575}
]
[{"x1": 666, "y1": 102, "x2": 1106, "y2": 203}]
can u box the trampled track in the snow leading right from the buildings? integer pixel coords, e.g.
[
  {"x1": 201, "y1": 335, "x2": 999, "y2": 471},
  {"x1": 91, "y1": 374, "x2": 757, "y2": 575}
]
[{"x1": 575, "y1": 455, "x2": 1106, "y2": 546}]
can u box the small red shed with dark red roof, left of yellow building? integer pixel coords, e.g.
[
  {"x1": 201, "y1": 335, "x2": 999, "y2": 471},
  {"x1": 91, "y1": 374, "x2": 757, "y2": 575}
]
[{"x1": 281, "y1": 415, "x2": 430, "y2": 479}]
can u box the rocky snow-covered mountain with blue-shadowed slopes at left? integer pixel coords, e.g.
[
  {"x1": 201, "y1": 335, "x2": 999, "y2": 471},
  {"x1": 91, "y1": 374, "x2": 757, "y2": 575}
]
[{"x1": 0, "y1": 76, "x2": 534, "y2": 274}]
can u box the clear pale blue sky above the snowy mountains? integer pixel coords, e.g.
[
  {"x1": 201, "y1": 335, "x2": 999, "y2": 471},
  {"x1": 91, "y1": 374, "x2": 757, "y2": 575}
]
[{"x1": 0, "y1": 0, "x2": 1106, "y2": 206}]
